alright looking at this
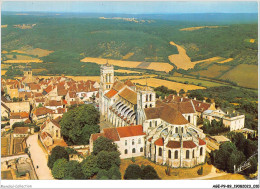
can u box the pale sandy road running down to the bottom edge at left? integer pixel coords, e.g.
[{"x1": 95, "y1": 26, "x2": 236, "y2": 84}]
[{"x1": 26, "y1": 134, "x2": 54, "y2": 180}]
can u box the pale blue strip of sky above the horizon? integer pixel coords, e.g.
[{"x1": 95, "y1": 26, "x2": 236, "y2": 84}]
[{"x1": 1, "y1": 1, "x2": 258, "y2": 14}]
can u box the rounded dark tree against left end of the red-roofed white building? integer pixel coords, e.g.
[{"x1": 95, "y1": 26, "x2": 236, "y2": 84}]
[{"x1": 93, "y1": 136, "x2": 117, "y2": 155}]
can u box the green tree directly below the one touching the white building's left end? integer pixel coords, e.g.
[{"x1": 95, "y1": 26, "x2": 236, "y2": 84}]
[{"x1": 97, "y1": 151, "x2": 121, "y2": 170}]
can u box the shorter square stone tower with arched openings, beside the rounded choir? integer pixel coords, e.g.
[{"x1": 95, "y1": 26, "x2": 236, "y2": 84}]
[{"x1": 137, "y1": 86, "x2": 156, "y2": 124}]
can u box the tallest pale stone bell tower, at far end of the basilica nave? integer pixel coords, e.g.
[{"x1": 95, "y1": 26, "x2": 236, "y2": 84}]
[{"x1": 99, "y1": 62, "x2": 114, "y2": 115}]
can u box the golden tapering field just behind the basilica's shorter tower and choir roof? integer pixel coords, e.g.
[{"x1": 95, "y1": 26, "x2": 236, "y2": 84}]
[{"x1": 131, "y1": 78, "x2": 205, "y2": 91}]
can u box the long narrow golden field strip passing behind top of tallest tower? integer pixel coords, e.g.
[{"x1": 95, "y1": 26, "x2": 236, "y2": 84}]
[{"x1": 81, "y1": 57, "x2": 173, "y2": 72}]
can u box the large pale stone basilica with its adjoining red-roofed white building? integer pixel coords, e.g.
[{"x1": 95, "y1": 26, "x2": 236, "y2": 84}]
[{"x1": 98, "y1": 64, "x2": 206, "y2": 168}]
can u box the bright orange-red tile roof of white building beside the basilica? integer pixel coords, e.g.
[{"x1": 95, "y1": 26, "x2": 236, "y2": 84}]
[{"x1": 116, "y1": 125, "x2": 145, "y2": 138}]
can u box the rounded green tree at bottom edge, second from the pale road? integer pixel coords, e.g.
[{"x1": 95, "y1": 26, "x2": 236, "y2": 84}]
[{"x1": 65, "y1": 160, "x2": 84, "y2": 179}]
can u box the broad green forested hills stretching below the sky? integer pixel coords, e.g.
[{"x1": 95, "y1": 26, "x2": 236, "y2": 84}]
[{"x1": 2, "y1": 12, "x2": 258, "y2": 79}]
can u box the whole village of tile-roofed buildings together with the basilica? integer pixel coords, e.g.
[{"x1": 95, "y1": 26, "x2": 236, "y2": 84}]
[{"x1": 1, "y1": 64, "x2": 256, "y2": 180}]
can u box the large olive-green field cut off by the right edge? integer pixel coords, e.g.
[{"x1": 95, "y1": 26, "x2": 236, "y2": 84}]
[{"x1": 221, "y1": 64, "x2": 258, "y2": 89}]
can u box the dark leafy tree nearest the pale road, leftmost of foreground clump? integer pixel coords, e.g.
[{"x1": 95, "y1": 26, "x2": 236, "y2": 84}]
[{"x1": 48, "y1": 146, "x2": 69, "y2": 169}]
